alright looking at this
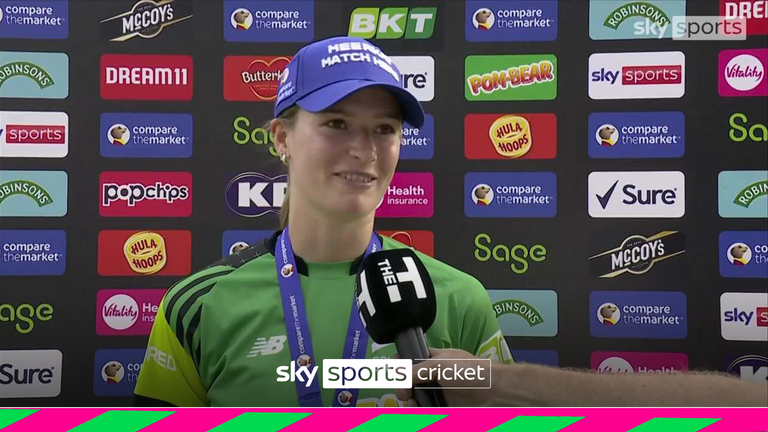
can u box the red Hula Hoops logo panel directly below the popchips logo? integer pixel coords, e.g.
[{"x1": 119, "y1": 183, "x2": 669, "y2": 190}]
[{"x1": 98, "y1": 230, "x2": 192, "y2": 276}]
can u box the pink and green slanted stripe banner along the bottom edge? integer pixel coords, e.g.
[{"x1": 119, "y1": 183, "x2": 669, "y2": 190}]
[{"x1": 0, "y1": 408, "x2": 768, "y2": 432}]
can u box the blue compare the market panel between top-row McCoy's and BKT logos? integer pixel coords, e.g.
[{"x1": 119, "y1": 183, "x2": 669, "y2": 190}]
[{"x1": 224, "y1": 0, "x2": 315, "y2": 42}]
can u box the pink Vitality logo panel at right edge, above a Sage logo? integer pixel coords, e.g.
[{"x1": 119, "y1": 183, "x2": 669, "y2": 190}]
[{"x1": 717, "y1": 48, "x2": 768, "y2": 97}]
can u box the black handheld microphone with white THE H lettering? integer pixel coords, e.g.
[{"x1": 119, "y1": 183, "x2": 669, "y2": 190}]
[{"x1": 355, "y1": 249, "x2": 447, "y2": 407}]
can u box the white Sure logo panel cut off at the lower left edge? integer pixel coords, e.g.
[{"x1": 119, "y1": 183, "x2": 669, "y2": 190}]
[{"x1": 0, "y1": 350, "x2": 62, "y2": 399}]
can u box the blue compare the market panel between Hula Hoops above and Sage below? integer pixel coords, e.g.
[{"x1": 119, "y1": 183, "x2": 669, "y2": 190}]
[{"x1": 464, "y1": 172, "x2": 557, "y2": 218}]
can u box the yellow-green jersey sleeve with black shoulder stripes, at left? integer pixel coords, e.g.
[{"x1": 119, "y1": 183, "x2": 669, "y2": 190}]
[{"x1": 134, "y1": 266, "x2": 233, "y2": 407}]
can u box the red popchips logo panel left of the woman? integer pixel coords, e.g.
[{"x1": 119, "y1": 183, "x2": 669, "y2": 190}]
[{"x1": 99, "y1": 171, "x2": 192, "y2": 217}]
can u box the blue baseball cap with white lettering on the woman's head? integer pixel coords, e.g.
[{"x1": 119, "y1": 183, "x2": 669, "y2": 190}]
[{"x1": 274, "y1": 37, "x2": 424, "y2": 127}]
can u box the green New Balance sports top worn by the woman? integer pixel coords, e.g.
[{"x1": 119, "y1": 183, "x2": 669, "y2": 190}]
[{"x1": 134, "y1": 232, "x2": 512, "y2": 407}]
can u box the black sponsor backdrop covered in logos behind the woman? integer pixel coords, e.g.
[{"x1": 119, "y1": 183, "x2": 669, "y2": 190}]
[{"x1": 0, "y1": 0, "x2": 768, "y2": 406}]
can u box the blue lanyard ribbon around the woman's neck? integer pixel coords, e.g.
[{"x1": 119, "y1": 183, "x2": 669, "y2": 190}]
[{"x1": 275, "y1": 227, "x2": 381, "y2": 407}]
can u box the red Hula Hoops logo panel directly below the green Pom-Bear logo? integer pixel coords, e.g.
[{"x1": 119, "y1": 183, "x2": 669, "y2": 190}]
[{"x1": 464, "y1": 113, "x2": 557, "y2": 160}]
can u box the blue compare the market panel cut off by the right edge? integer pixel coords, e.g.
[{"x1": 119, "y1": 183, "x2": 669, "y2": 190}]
[{"x1": 718, "y1": 231, "x2": 768, "y2": 278}]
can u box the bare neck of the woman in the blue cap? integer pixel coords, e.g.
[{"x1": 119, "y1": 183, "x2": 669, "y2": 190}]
[{"x1": 288, "y1": 205, "x2": 373, "y2": 262}]
